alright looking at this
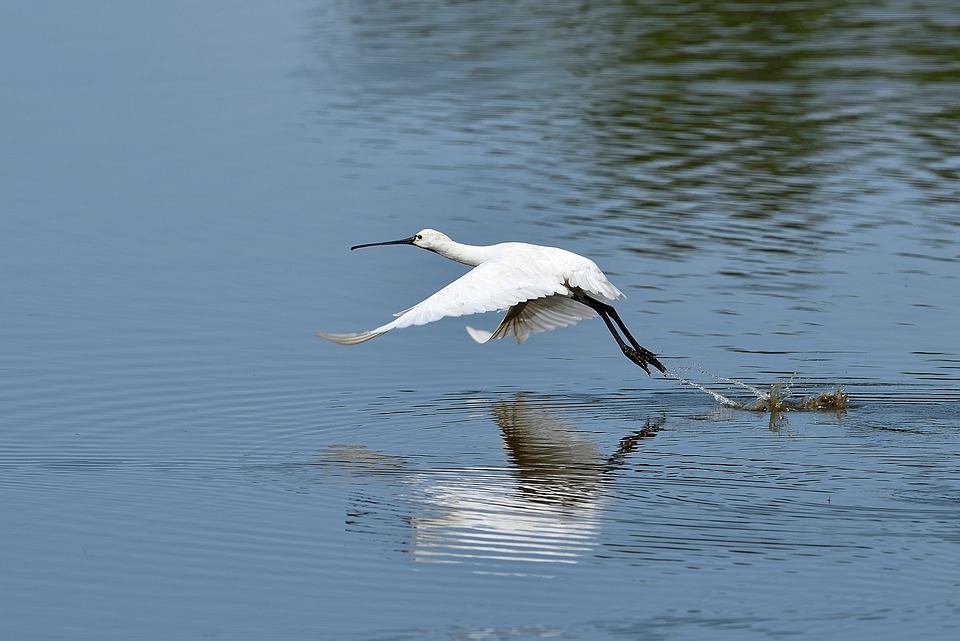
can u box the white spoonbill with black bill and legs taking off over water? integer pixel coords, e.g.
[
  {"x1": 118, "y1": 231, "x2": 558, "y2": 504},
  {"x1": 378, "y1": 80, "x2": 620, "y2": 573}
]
[{"x1": 317, "y1": 229, "x2": 666, "y2": 374}]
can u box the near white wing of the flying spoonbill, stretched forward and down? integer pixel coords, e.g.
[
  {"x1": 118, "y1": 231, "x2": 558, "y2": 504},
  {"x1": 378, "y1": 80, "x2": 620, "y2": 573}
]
[{"x1": 317, "y1": 258, "x2": 568, "y2": 345}]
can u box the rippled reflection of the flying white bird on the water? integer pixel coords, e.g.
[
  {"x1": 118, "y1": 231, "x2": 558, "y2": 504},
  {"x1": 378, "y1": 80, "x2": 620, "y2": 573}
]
[{"x1": 328, "y1": 395, "x2": 663, "y2": 571}]
